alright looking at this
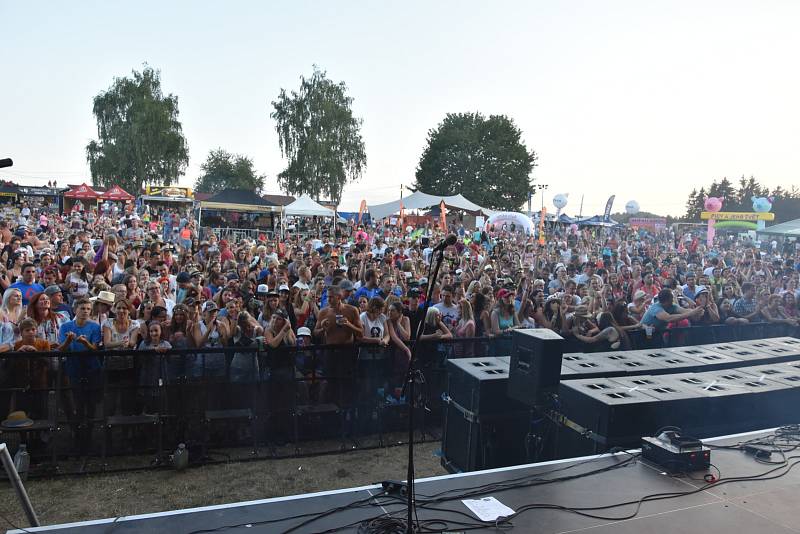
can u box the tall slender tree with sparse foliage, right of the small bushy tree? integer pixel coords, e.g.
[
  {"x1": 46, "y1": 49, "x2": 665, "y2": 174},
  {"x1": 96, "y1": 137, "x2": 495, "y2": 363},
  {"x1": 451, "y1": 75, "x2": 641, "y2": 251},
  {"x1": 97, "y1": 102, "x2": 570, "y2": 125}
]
[{"x1": 270, "y1": 65, "x2": 367, "y2": 203}]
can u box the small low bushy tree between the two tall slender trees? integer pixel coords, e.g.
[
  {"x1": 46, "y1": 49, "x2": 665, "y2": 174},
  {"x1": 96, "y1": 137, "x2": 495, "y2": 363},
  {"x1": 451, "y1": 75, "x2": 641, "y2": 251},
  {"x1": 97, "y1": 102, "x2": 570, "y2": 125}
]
[{"x1": 194, "y1": 148, "x2": 267, "y2": 195}]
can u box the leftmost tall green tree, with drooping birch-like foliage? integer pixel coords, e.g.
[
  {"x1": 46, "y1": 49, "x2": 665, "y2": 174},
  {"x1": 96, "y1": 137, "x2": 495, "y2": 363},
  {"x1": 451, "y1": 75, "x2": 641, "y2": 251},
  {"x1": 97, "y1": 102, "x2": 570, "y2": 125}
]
[{"x1": 86, "y1": 65, "x2": 189, "y2": 194}]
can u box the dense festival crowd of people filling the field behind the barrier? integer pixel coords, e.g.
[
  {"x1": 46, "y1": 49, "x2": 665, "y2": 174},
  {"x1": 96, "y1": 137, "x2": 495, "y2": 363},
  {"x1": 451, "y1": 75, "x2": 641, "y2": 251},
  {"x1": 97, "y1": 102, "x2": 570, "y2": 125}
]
[{"x1": 0, "y1": 201, "x2": 800, "y2": 432}]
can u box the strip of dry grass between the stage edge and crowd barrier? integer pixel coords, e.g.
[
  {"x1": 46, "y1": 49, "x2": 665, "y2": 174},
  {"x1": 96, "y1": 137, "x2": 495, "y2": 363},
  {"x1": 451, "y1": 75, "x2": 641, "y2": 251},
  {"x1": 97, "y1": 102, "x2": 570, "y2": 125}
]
[{"x1": 0, "y1": 442, "x2": 445, "y2": 526}]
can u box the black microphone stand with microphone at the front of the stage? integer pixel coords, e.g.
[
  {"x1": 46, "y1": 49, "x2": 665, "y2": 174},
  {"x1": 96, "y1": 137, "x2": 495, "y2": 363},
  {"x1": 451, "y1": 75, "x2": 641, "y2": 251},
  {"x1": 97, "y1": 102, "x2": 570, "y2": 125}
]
[{"x1": 403, "y1": 248, "x2": 444, "y2": 534}]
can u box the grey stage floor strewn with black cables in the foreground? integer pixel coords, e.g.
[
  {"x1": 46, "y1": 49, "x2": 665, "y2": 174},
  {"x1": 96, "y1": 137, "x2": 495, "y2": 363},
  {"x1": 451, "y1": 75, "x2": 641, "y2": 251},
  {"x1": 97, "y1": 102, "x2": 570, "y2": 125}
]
[{"x1": 9, "y1": 429, "x2": 800, "y2": 534}]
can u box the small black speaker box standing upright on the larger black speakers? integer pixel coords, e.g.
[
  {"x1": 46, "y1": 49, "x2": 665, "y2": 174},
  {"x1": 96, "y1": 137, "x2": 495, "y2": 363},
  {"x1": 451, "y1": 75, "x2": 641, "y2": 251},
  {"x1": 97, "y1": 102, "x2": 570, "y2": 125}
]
[{"x1": 508, "y1": 328, "x2": 564, "y2": 406}]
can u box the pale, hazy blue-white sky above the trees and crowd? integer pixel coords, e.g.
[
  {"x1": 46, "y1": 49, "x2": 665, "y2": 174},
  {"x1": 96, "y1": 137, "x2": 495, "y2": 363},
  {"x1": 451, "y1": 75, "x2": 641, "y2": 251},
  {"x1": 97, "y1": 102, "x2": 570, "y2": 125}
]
[{"x1": 0, "y1": 0, "x2": 800, "y2": 215}]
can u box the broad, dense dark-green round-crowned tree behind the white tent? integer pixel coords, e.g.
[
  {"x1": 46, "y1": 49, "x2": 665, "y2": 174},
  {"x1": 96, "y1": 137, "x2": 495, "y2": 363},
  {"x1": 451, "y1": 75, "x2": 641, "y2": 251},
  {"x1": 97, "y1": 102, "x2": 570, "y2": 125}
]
[{"x1": 414, "y1": 113, "x2": 536, "y2": 211}]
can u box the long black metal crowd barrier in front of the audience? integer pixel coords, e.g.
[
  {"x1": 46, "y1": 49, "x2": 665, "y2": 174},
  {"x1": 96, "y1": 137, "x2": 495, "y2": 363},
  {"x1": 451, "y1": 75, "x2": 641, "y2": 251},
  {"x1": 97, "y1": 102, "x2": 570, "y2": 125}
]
[{"x1": 0, "y1": 323, "x2": 798, "y2": 478}]
